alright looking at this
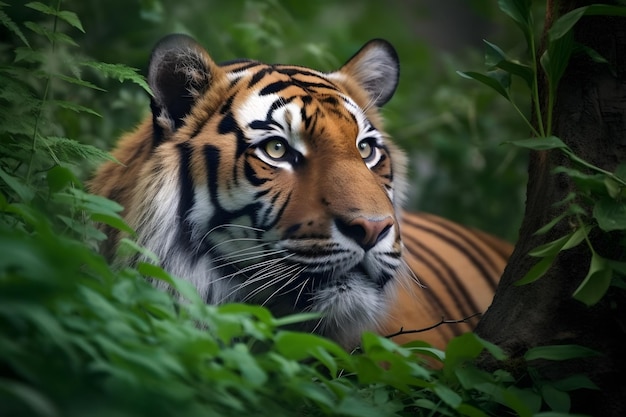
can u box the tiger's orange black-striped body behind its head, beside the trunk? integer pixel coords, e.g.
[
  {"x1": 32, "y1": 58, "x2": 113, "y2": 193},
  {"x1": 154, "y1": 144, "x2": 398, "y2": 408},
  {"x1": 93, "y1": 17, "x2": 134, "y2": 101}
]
[{"x1": 380, "y1": 212, "x2": 513, "y2": 348}]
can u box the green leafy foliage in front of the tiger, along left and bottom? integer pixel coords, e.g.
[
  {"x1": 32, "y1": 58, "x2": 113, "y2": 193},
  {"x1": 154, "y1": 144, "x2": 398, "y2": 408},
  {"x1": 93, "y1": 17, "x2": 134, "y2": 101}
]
[{"x1": 0, "y1": 1, "x2": 600, "y2": 416}]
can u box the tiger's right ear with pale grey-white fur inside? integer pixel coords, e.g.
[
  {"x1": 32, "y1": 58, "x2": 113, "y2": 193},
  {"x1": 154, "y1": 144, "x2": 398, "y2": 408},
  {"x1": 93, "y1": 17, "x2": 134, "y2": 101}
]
[{"x1": 337, "y1": 39, "x2": 400, "y2": 107}]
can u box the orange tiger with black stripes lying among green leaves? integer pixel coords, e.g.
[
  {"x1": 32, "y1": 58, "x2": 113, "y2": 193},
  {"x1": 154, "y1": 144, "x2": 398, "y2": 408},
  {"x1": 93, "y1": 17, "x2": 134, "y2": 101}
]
[{"x1": 90, "y1": 34, "x2": 509, "y2": 349}]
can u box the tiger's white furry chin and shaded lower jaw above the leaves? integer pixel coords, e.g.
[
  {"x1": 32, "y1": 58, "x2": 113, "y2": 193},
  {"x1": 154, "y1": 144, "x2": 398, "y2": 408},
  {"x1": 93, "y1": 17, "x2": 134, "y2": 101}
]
[{"x1": 210, "y1": 249, "x2": 395, "y2": 348}]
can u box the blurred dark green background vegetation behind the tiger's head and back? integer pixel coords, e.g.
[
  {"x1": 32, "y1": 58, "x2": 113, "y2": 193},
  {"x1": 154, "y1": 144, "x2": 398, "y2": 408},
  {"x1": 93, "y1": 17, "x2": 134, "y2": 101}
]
[{"x1": 6, "y1": 0, "x2": 528, "y2": 241}]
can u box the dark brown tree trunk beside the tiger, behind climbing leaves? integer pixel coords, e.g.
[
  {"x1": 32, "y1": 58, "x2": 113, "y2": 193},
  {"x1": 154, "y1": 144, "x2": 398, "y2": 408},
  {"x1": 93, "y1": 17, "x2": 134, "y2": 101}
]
[{"x1": 476, "y1": 0, "x2": 626, "y2": 416}]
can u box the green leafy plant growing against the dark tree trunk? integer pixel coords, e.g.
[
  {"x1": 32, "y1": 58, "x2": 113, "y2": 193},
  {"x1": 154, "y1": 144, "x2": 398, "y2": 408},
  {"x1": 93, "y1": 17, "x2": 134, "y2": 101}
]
[{"x1": 460, "y1": 0, "x2": 626, "y2": 305}]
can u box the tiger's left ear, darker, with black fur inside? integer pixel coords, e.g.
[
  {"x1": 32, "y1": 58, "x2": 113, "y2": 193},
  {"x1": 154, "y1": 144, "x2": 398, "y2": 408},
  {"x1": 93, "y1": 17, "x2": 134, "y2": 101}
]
[{"x1": 148, "y1": 34, "x2": 216, "y2": 140}]
